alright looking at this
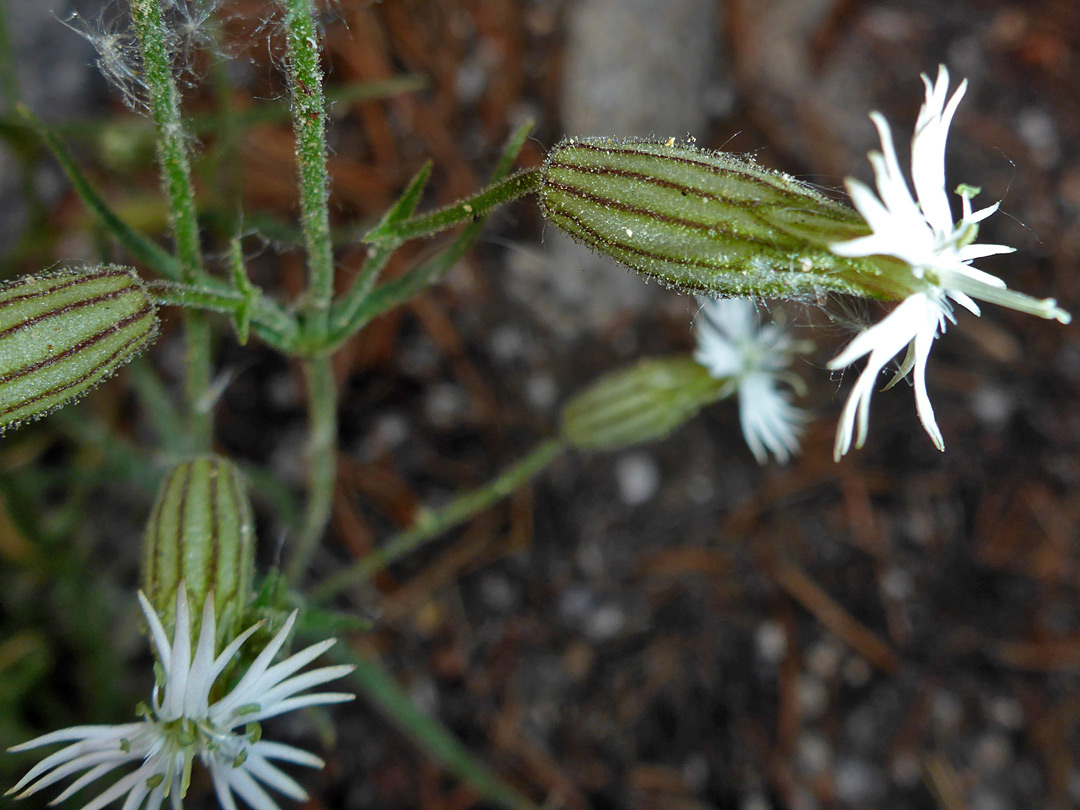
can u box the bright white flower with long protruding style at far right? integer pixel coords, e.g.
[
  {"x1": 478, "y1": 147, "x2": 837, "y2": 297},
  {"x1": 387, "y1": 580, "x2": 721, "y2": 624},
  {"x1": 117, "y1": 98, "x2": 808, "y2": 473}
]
[{"x1": 828, "y1": 65, "x2": 1070, "y2": 460}]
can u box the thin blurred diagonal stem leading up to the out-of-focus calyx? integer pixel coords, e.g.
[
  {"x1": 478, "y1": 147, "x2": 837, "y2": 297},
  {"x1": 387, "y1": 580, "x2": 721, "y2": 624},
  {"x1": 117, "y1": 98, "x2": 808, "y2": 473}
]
[{"x1": 311, "y1": 438, "x2": 566, "y2": 603}]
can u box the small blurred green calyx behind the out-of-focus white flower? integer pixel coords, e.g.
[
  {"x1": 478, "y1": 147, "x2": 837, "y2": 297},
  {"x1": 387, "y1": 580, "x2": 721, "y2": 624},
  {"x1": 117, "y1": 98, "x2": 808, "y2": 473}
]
[{"x1": 563, "y1": 357, "x2": 732, "y2": 450}]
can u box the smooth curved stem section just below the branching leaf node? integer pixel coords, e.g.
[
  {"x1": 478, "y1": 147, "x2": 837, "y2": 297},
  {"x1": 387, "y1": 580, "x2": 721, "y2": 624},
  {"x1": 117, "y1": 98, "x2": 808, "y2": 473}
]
[{"x1": 285, "y1": 354, "x2": 337, "y2": 584}]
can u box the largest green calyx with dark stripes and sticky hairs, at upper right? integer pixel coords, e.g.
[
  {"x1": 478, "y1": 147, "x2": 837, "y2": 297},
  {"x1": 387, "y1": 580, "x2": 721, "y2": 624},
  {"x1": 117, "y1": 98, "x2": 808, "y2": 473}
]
[{"x1": 538, "y1": 138, "x2": 910, "y2": 299}]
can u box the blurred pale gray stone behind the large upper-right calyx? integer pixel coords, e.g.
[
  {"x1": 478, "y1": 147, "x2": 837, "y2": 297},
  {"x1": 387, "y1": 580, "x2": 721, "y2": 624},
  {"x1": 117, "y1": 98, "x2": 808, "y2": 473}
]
[{"x1": 526, "y1": 0, "x2": 729, "y2": 338}]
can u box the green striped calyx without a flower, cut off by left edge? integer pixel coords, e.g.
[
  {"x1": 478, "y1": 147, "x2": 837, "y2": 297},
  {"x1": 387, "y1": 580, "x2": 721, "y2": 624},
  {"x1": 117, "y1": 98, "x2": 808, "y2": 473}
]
[{"x1": 0, "y1": 265, "x2": 158, "y2": 433}]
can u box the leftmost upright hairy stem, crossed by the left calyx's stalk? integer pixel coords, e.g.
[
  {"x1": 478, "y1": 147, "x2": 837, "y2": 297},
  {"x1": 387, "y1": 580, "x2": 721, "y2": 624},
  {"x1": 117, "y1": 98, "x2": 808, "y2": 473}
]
[{"x1": 131, "y1": 0, "x2": 213, "y2": 449}]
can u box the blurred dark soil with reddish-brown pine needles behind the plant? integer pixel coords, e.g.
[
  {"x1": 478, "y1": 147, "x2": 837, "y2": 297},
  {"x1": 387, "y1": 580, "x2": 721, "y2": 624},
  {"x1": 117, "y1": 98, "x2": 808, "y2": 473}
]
[{"x1": 0, "y1": 0, "x2": 1080, "y2": 810}]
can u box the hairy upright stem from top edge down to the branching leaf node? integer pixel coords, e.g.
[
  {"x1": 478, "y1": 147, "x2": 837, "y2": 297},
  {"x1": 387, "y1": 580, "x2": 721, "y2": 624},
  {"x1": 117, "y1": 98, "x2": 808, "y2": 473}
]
[{"x1": 280, "y1": 0, "x2": 334, "y2": 335}]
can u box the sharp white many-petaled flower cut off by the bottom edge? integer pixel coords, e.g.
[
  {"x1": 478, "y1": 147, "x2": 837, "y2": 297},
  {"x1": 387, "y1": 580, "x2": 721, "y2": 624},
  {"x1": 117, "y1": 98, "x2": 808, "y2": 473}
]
[{"x1": 8, "y1": 585, "x2": 354, "y2": 810}]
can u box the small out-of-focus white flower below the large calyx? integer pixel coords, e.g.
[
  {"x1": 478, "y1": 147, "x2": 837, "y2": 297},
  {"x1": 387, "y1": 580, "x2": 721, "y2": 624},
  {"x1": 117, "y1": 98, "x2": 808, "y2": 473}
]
[{"x1": 693, "y1": 298, "x2": 806, "y2": 464}]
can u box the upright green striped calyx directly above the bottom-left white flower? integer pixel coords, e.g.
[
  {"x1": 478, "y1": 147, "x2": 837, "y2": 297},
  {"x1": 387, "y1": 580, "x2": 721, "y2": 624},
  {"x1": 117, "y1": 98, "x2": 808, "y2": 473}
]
[{"x1": 143, "y1": 455, "x2": 255, "y2": 642}]
